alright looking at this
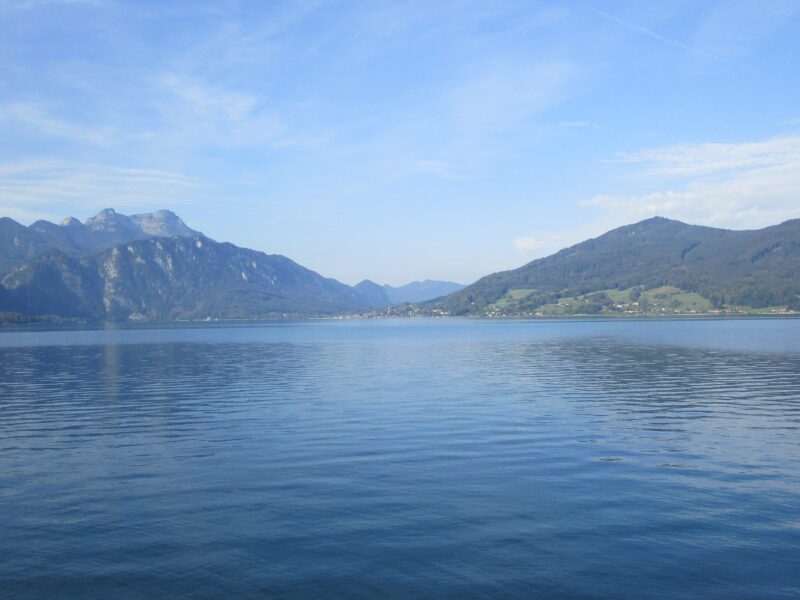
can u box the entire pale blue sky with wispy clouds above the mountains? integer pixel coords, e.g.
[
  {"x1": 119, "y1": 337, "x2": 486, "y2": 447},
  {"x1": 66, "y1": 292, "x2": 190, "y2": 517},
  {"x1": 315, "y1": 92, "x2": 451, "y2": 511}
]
[{"x1": 0, "y1": 0, "x2": 800, "y2": 284}]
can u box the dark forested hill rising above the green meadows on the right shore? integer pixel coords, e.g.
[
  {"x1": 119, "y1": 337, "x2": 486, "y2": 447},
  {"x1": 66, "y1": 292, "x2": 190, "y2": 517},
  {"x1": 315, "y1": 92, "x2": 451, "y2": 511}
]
[{"x1": 432, "y1": 217, "x2": 800, "y2": 315}]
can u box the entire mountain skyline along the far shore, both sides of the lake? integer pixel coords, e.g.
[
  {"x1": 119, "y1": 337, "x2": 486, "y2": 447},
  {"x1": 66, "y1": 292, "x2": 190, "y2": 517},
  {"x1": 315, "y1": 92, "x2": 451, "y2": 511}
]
[{"x1": 0, "y1": 209, "x2": 800, "y2": 320}]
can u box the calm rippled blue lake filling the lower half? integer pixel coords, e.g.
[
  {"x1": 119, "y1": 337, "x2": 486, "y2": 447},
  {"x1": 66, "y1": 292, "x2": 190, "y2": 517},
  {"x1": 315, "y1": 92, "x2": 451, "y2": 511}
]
[{"x1": 0, "y1": 320, "x2": 800, "y2": 599}]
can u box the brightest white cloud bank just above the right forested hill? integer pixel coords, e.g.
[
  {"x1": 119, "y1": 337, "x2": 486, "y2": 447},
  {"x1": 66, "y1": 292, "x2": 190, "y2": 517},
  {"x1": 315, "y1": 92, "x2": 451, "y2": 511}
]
[{"x1": 583, "y1": 136, "x2": 800, "y2": 228}]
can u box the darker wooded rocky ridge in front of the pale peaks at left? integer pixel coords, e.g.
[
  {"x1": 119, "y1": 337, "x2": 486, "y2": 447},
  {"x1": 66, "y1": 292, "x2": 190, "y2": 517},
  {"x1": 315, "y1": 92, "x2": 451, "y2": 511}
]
[{"x1": 0, "y1": 235, "x2": 367, "y2": 320}]
